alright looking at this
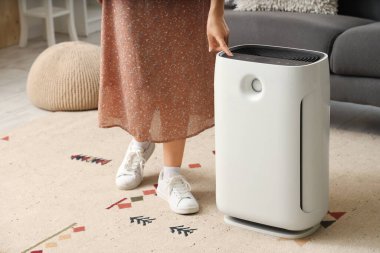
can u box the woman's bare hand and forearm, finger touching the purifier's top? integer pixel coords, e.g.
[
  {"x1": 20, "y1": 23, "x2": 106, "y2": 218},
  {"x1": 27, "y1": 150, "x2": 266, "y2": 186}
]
[{"x1": 207, "y1": 0, "x2": 233, "y2": 56}]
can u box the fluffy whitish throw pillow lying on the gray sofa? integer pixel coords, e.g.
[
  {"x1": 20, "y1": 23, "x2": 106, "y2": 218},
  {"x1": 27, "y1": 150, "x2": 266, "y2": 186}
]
[{"x1": 234, "y1": 0, "x2": 338, "y2": 14}]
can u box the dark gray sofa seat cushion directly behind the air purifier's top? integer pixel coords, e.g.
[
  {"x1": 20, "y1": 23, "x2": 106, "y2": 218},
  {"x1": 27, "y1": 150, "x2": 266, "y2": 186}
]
[{"x1": 225, "y1": 10, "x2": 373, "y2": 53}]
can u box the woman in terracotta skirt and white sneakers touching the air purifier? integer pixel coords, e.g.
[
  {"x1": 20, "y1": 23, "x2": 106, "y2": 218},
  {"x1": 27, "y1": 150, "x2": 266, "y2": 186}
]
[{"x1": 98, "y1": 0, "x2": 232, "y2": 214}]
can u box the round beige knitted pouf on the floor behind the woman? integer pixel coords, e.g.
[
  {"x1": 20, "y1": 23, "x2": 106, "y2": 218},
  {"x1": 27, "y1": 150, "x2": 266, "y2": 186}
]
[{"x1": 26, "y1": 41, "x2": 100, "y2": 111}]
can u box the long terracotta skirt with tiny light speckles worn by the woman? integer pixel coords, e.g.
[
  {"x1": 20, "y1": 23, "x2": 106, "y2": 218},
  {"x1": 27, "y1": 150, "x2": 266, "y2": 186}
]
[{"x1": 98, "y1": 0, "x2": 215, "y2": 143}]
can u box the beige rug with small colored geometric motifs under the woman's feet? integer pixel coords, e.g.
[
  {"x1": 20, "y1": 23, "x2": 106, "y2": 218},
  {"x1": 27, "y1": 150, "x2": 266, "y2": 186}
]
[{"x1": 0, "y1": 111, "x2": 380, "y2": 253}]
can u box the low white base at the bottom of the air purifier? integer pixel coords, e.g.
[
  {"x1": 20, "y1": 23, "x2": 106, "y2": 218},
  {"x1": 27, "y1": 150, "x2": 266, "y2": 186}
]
[{"x1": 224, "y1": 215, "x2": 320, "y2": 239}]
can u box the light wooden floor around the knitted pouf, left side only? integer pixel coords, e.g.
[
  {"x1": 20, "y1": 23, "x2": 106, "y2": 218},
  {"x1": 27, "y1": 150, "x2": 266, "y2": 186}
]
[{"x1": 0, "y1": 32, "x2": 100, "y2": 134}]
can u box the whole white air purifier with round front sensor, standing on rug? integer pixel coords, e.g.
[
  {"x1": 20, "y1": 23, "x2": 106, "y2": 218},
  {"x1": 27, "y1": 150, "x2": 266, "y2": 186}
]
[{"x1": 214, "y1": 45, "x2": 330, "y2": 238}]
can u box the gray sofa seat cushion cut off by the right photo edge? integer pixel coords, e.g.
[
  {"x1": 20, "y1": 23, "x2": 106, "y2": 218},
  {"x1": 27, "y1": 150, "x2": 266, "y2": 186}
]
[{"x1": 330, "y1": 22, "x2": 380, "y2": 77}]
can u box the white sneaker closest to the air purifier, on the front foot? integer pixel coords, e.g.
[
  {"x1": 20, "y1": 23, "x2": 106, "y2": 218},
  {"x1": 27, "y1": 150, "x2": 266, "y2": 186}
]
[{"x1": 157, "y1": 170, "x2": 199, "y2": 214}]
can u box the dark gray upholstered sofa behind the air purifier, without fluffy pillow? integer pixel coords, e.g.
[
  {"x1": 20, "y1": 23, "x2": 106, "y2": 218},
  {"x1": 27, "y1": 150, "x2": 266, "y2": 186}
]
[{"x1": 225, "y1": 0, "x2": 380, "y2": 106}]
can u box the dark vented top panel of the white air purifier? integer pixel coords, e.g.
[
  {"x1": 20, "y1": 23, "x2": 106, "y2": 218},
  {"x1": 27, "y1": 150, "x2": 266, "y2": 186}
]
[{"x1": 220, "y1": 45, "x2": 324, "y2": 66}]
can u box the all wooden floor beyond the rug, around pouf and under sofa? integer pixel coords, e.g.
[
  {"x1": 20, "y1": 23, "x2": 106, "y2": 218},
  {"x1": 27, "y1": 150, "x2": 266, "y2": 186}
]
[{"x1": 0, "y1": 33, "x2": 380, "y2": 137}]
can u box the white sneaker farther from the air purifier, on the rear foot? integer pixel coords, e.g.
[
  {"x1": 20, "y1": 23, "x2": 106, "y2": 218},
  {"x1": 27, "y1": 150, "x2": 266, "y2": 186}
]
[{"x1": 115, "y1": 140, "x2": 155, "y2": 190}]
